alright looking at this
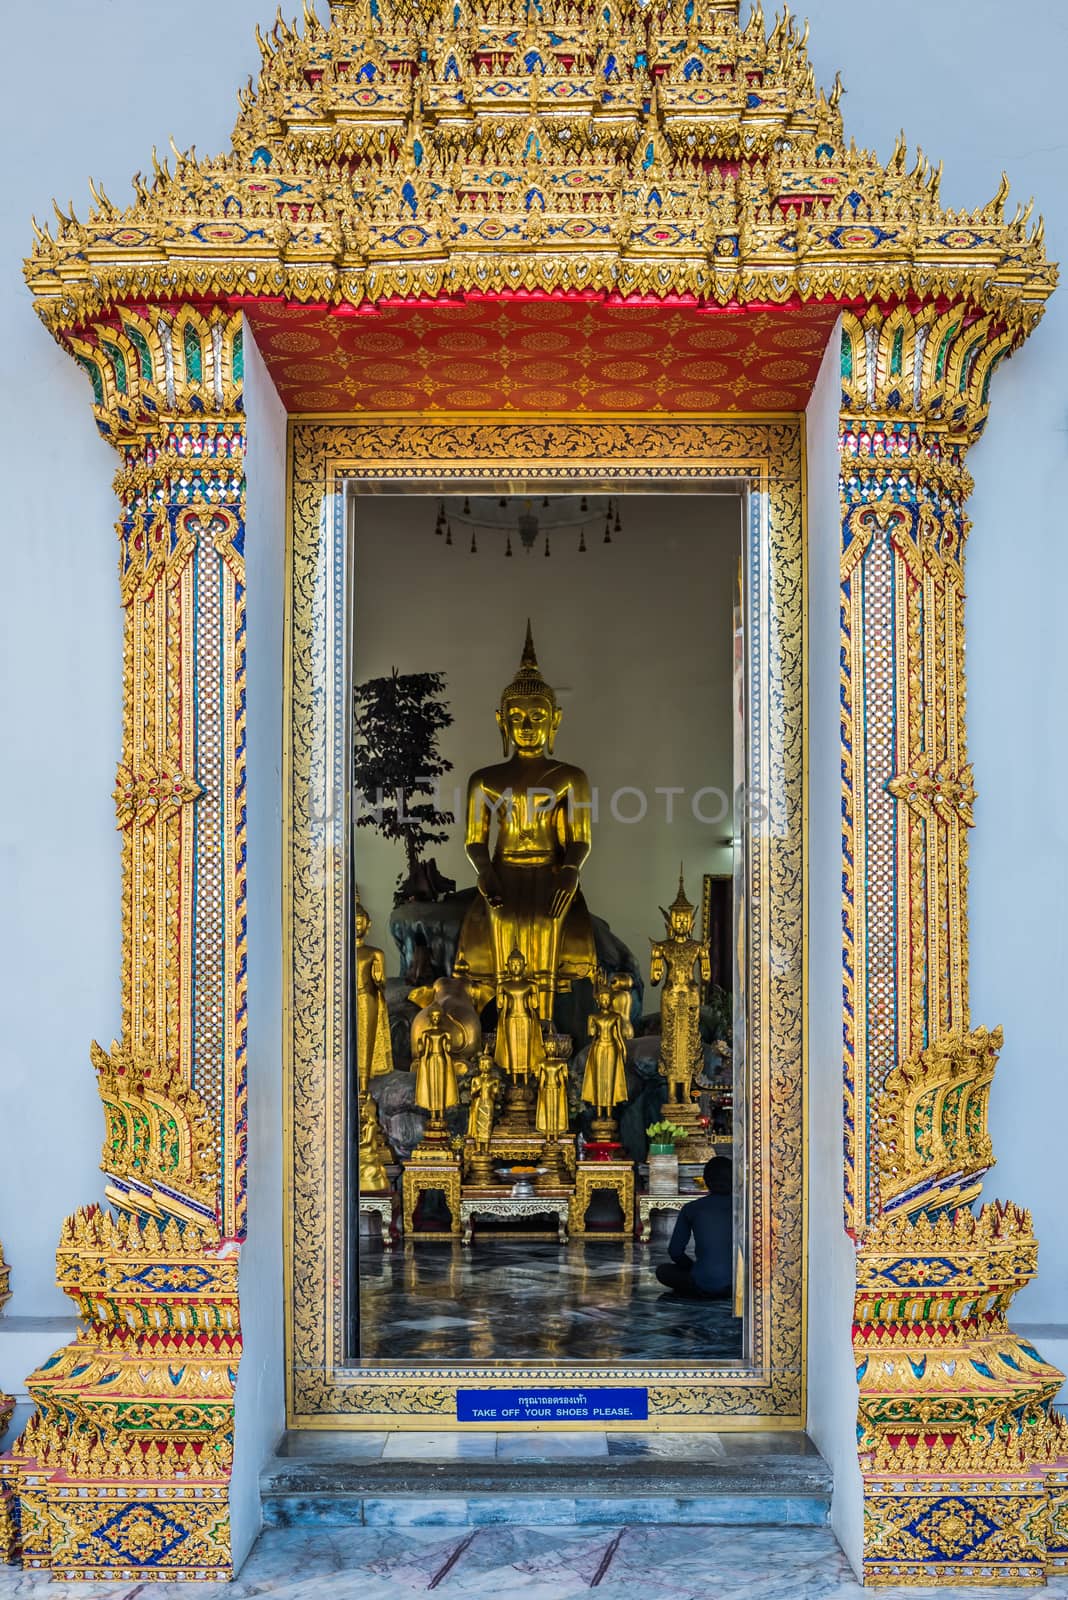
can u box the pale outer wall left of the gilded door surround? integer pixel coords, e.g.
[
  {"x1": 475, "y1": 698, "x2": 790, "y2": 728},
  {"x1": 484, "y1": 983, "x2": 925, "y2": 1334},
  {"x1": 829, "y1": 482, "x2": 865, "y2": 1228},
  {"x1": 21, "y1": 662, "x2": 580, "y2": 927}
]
[{"x1": 0, "y1": 0, "x2": 267, "y2": 1394}]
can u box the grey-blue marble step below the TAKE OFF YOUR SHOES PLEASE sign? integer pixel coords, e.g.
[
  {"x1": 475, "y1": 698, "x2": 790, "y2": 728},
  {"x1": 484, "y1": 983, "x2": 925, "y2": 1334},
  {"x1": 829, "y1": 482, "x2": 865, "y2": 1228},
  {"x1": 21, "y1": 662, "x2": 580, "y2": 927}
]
[{"x1": 261, "y1": 1432, "x2": 831, "y2": 1528}]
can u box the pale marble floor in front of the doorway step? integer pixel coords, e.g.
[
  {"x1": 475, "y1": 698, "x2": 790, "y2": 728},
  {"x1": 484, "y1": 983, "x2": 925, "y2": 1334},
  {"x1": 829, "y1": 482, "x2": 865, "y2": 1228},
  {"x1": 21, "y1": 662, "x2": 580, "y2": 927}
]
[{"x1": 0, "y1": 1526, "x2": 1068, "y2": 1600}]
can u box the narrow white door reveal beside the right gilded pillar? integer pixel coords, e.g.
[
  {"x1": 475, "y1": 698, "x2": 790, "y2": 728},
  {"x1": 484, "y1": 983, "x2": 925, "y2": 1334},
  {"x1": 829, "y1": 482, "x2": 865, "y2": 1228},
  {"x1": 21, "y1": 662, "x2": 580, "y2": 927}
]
[{"x1": 806, "y1": 328, "x2": 863, "y2": 1570}]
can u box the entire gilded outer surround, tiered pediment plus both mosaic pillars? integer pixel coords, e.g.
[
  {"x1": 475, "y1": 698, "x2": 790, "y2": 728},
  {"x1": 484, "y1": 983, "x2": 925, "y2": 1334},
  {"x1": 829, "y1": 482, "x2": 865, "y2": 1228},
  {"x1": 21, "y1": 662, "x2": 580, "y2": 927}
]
[{"x1": 12, "y1": 0, "x2": 1068, "y2": 1582}]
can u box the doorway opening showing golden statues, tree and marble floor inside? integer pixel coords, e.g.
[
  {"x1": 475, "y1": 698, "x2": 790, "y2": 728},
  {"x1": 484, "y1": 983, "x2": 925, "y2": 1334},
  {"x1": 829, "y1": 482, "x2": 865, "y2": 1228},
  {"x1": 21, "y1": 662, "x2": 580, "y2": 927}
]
[{"x1": 347, "y1": 485, "x2": 759, "y2": 1366}]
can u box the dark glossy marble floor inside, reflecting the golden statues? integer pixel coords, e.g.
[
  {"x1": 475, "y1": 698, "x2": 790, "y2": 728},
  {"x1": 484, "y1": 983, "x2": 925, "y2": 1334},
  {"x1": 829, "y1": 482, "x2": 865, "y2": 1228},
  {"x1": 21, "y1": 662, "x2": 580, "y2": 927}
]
[{"x1": 360, "y1": 1237, "x2": 742, "y2": 1366}]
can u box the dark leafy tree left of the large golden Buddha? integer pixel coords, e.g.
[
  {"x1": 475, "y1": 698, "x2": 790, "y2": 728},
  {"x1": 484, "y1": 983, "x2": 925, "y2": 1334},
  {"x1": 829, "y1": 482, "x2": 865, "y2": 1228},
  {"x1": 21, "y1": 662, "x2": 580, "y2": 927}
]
[{"x1": 353, "y1": 667, "x2": 454, "y2": 904}]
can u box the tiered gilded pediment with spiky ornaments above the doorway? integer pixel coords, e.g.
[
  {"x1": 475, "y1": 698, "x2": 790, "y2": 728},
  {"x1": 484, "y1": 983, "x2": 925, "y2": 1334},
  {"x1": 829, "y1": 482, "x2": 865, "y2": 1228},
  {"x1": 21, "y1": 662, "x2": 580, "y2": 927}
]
[{"x1": 26, "y1": 0, "x2": 1055, "y2": 339}]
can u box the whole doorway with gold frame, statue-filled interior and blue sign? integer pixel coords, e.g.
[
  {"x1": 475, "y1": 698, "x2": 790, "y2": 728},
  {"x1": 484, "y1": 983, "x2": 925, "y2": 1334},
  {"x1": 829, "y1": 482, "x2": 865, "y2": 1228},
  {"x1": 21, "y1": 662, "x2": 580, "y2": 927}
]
[{"x1": 286, "y1": 418, "x2": 804, "y2": 1427}]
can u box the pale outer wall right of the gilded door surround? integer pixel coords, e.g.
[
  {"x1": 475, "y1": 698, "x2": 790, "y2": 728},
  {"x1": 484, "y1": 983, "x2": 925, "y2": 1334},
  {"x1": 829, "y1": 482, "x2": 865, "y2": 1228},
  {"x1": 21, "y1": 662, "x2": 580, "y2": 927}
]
[{"x1": 804, "y1": 0, "x2": 1068, "y2": 1324}]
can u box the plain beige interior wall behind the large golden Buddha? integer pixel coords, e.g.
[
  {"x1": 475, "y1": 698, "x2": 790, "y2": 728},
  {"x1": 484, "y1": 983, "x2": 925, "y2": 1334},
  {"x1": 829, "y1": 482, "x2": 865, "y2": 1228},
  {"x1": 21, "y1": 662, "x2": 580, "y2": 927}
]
[{"x1": 353, "y1": 494, "x2": 740, "y2": 978}]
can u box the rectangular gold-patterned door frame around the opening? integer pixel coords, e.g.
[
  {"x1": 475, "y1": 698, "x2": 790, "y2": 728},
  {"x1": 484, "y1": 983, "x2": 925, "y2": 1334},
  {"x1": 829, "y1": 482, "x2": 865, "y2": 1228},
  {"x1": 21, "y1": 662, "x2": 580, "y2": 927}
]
[{"x1": 285, "y1": 416, "x2": 806, "y2": 1429}]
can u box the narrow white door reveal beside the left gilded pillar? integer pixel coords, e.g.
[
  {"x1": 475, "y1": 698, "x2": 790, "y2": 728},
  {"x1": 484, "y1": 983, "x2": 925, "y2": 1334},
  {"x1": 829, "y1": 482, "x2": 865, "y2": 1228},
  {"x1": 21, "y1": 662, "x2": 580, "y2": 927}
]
[{"x1": 230, "y1": 323, "x2": 286, "y2": 1565}]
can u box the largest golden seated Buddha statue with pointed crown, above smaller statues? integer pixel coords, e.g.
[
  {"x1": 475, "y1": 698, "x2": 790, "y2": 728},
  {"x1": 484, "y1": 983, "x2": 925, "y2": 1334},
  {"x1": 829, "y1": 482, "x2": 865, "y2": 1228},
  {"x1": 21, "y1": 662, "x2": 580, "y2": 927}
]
[{"x1": 459, "y1": 622, "x2": 596, "y2": 1022}]
